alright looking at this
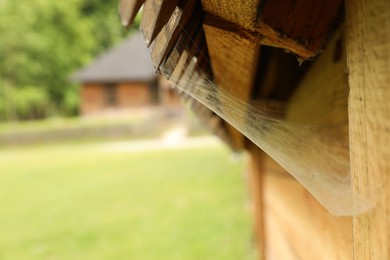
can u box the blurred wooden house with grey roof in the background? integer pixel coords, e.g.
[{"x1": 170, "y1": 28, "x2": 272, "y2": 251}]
[{"x1": 73, "y1": 32, "x2": 180, "y2": 116}]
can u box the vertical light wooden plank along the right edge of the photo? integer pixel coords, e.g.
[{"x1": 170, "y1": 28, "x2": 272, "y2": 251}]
[{"x1": 346, "y1": 0, "x2": 390, "y2": 259}]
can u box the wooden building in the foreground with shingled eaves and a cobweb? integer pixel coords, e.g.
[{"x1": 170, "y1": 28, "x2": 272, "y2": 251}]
[{"x1": 119, "y1": 0, "x2": 390, "y2": 260}]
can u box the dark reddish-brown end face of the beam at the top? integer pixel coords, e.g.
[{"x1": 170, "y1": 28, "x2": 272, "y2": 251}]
[{"x1": 257, "y1": 0, "x2": 343, "y2": 52}]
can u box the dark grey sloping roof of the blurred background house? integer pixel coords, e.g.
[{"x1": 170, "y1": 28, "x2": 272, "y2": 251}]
[{"x1": 72, "y1": 32, "x2": 156, "y2": 82}]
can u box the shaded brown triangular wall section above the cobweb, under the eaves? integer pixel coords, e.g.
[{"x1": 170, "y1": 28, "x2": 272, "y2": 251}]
[{"x1": 286, "y1": 26, "x2": 349, "y2": 148}]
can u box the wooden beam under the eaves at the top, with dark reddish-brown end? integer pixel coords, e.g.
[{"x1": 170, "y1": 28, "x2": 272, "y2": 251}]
[{"x1": 202, "y1": 0, "x2": 343, "y2": 59}]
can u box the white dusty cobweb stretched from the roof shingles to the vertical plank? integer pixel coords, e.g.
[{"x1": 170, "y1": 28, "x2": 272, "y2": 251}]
[{"x1": 149, "y1": 24, "x2": 372, "y2": 215}]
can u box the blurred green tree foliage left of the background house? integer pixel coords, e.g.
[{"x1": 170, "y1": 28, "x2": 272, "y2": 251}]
[{"x1": 0, "y1": 0, "x2": 137, "y2": 120}]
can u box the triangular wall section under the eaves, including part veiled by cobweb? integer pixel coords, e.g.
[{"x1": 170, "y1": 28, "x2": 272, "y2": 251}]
[{"x1": 256, "y1": 26, "x2": 352, "y2": 215}]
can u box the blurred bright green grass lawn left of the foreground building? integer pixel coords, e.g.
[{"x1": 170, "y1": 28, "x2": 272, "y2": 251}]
[{"x1": 0, "y1": 139, "x2": 253, "y2": 260}]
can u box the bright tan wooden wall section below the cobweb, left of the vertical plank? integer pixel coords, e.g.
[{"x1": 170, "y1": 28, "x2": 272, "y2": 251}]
[{"x1": 262, "y1": 155, "x2": 352, "y2": 260}]
